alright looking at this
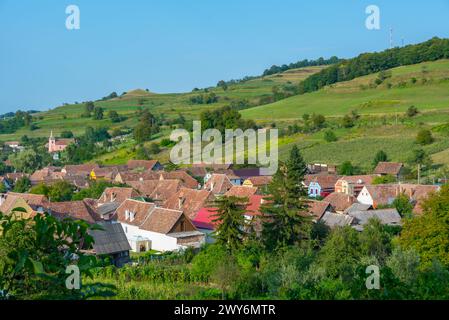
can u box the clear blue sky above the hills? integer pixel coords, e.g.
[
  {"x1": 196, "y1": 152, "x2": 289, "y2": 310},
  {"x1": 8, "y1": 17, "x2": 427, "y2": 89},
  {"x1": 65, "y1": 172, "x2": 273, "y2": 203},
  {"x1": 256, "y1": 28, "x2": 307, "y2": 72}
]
[{"x1": 0, "y1": 0, "x2": 449, "y2": 113}]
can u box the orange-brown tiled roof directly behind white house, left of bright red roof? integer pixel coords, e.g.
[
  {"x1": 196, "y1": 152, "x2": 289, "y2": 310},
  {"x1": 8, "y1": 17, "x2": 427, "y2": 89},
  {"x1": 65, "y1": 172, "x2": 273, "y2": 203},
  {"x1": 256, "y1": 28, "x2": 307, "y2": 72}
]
[{"x1": 163, "y1": 188, "x2": 213, "y2": 219}]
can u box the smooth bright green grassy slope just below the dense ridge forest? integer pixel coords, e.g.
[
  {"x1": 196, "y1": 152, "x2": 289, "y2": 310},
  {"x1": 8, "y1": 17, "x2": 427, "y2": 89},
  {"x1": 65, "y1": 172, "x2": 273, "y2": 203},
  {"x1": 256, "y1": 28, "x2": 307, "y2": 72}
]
[{"x1": 242, "y1": 60, "x2": 449, "y2": 120}]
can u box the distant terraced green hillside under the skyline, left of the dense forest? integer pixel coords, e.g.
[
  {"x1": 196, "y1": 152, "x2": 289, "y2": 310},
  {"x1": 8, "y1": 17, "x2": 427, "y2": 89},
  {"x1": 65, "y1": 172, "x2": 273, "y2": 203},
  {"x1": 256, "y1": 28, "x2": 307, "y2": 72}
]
[{"x1": 0, "y1": 67, "x2": 324, "y2": 141}]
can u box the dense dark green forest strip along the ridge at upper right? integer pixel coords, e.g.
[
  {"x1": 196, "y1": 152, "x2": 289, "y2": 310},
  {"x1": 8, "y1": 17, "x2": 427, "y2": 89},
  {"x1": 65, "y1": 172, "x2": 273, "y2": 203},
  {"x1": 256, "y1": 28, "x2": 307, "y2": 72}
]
[{"x1": 299, "y1": 38, "x2": 449, "y2": 94}]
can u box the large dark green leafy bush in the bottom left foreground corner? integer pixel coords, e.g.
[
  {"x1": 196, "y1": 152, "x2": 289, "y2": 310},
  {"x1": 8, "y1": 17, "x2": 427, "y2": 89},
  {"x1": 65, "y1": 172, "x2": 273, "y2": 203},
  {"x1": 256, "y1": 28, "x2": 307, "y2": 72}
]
[{"x1": 0, "y1": 214, "x2": 95, "y2": 299}]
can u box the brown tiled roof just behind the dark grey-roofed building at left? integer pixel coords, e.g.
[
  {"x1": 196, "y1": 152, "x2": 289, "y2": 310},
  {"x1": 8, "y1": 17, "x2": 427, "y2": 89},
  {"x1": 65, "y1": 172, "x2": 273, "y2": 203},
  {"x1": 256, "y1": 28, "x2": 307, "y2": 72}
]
[{"x1": 44, "y1": 199, "x2": 101, "y2": 223}]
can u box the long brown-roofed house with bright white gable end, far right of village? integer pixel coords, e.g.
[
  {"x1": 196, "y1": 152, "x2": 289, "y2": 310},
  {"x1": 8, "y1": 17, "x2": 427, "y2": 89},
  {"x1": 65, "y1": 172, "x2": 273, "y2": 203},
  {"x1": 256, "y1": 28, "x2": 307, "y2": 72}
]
[{"x1": 357, "y1": 184, "x2": 439, "y2": 214}]
